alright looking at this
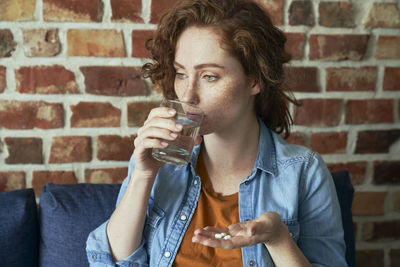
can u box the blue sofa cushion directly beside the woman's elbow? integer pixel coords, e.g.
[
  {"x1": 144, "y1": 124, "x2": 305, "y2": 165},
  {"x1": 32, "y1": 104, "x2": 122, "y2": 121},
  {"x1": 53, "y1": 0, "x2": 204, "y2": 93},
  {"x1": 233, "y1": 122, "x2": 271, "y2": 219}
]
[{"x1": 39, "y1": 184, "x2": 121, "y2": 267}]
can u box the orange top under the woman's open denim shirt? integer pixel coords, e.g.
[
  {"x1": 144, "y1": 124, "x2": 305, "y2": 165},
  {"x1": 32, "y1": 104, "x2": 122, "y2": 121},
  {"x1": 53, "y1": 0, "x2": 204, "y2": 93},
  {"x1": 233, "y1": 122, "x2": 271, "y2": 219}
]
[{"x1": 172, "y1": 156, "x2": 243, "y2": 267}]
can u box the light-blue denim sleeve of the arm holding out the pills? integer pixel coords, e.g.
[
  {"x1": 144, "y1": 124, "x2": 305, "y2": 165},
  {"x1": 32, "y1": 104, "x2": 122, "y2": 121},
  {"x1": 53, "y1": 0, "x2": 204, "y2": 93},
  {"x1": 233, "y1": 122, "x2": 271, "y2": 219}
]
[{"x1": 298, "y1": 154, "x2": 347, "y2": 266}]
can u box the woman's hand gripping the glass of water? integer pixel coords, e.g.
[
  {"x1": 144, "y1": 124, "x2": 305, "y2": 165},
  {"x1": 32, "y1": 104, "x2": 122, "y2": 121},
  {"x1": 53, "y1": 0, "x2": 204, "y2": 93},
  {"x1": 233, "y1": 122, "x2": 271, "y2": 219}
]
[{"x1": 133, "y1": 107, "x2": 182, "y2": 178}]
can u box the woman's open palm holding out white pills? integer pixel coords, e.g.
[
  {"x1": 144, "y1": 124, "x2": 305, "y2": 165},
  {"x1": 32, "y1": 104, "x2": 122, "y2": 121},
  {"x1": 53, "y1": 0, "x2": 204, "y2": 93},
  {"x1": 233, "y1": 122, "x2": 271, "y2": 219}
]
[{"x1": 192, "y1": 212, "x2": 289, "y2": 249}]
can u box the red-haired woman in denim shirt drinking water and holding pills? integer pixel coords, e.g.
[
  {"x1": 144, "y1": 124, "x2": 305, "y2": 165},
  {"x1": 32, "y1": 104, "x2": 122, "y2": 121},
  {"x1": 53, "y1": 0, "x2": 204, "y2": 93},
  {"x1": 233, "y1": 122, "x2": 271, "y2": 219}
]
[{"x1": 87, "y1": 0, "x2": 346, "y2": 267}]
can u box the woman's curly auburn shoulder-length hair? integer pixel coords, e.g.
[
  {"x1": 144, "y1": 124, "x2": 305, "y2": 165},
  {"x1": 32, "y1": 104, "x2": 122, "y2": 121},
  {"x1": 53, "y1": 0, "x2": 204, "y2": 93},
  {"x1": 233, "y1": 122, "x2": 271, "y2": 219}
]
[{"x1": 142, "y1": 0, "x2": 297, "y2": 138}]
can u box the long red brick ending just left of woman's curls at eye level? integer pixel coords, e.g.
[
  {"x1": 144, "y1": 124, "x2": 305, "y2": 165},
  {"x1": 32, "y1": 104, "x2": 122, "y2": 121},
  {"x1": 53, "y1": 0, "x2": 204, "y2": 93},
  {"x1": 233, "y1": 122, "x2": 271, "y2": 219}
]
[{"x1": 80, "y1": 66, "x2": 147, "y2": 96}]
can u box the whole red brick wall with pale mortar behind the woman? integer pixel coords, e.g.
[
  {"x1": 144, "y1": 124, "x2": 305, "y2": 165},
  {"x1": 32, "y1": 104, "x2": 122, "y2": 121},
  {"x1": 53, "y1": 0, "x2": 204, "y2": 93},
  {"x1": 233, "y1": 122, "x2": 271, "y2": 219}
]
[{"x1": 0, "y1": 0, "x2": 400, "y2": 266}]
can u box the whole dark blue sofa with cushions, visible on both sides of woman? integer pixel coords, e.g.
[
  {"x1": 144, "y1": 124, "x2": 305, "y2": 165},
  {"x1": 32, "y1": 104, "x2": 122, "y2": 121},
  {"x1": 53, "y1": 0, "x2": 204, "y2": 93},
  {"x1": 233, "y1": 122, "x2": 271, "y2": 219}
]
[{"x1": 0, "y1": 171, "x2": 355, "y2": 267}]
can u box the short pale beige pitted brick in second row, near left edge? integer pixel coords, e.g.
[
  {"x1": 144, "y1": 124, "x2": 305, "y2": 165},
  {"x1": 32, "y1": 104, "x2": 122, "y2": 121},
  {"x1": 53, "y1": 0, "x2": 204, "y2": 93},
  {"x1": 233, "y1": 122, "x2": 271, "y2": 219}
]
[{"x1": 22, "y1": 29, "x2": 61, "y2": 57}]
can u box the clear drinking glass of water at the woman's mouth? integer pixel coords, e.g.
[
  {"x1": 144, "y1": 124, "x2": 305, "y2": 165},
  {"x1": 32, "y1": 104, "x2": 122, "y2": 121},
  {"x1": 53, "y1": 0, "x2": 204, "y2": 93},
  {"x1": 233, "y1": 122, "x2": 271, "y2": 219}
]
[{"x1": 152, "y1": 99, "x2": 204, "y2": 165}]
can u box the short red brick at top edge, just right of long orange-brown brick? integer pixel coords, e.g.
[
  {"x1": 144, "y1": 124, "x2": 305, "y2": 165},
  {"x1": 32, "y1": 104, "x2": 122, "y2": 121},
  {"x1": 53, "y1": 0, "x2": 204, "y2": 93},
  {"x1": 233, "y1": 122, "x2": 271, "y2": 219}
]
[{"x1": 111, "y1": 0, "x2": 143, "y2": 22}]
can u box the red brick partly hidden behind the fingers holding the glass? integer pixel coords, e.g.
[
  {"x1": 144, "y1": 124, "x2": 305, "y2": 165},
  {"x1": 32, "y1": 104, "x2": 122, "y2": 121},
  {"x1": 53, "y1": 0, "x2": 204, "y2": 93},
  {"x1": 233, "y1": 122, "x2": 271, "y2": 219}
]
[{"x1": 127, "y1": 101, "x2": 160, "y2": 127}]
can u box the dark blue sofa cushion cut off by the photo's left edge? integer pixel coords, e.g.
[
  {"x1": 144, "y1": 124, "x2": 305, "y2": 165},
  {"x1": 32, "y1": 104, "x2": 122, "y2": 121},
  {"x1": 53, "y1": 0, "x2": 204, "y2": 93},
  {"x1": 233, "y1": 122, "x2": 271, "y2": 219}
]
[{"x1": 0, "y1": 189, "x2": 39, "y2": 267}]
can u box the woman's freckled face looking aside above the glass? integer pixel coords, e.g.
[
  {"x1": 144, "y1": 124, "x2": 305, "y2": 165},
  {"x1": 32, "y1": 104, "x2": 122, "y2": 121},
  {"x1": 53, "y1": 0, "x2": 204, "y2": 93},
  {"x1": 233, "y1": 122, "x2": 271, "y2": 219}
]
[{"x1": 174, "y1": 27, "x2": 259, "y2": 135}]
